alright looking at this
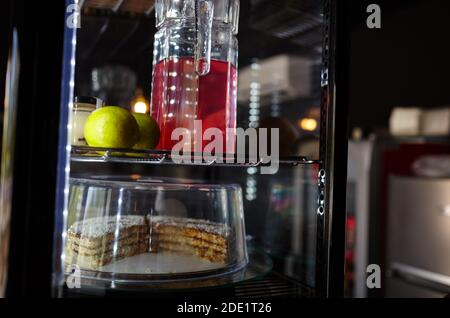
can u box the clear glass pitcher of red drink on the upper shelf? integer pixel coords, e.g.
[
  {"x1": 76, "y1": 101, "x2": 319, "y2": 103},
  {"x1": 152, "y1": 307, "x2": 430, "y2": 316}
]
[{"x1": 151, "y1": 0, "x2": 239, "y2": 153}]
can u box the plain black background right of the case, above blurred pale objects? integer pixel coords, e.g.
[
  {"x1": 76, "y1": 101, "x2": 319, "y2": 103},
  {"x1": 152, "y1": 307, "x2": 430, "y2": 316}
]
[{"x1": 349, "y1": 0, "x2": 450, "y2": 130}]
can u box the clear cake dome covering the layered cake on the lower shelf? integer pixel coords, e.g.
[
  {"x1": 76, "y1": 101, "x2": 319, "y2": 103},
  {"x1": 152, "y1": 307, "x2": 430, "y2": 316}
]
[{"x1": 63, "y1": 176, "x2": 248, "y2": 287}]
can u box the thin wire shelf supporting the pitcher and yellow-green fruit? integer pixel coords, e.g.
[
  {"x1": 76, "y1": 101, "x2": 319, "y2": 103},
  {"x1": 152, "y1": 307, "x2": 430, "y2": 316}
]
[{"x1": 71, "y1": 146, "x2": 320, "y2": 167}]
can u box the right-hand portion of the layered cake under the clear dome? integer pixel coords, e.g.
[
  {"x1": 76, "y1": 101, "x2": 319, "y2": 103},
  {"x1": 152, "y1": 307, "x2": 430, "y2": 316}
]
[{"x1": 151, "y1": 216, "x2": 229, "y2": 263}]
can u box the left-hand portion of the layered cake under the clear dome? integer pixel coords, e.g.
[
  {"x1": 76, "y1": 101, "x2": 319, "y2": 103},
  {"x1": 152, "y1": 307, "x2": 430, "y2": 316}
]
[{"x1": 66, "y1": 215, "x2": 150, "y2": 270}]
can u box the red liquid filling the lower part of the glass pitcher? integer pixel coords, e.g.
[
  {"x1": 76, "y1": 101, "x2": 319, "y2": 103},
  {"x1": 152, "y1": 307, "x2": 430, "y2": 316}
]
[{"x1": 152, "y1": 57, "x2": 237, "y2": 153}]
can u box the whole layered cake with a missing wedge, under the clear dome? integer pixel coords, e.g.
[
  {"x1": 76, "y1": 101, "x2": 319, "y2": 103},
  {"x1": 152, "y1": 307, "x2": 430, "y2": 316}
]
[{"x1": 65, "y1": 215, "x2": 230, "y2": 270}]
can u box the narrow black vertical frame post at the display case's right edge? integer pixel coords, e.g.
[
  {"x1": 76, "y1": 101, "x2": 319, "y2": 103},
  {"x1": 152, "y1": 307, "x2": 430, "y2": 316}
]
[{"x1": 316, "y1": 0, "x2": 350, "y2": 298}]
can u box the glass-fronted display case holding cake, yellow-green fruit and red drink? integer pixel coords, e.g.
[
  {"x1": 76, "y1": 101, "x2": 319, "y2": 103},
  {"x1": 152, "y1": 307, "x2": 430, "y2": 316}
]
[{"x1": 0, "y1": 0, "x2": 348, "y2": 298}]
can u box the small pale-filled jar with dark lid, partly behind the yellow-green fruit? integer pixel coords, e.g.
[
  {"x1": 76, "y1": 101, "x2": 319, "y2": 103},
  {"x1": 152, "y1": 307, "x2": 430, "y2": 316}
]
[{"x1": 70, "y1": 96, "x2": 103, "y2": 146}]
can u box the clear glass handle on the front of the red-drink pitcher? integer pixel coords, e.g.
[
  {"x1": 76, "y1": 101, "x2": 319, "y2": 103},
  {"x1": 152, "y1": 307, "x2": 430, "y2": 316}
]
[{"x1": 195, "y1": 0, "x2": 214, "y2": 76}]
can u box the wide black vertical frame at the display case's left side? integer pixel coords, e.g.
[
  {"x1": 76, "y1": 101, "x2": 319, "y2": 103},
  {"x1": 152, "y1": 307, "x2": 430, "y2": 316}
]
[{"x1": 0, "y1": 0, "x2": 65, "y2": 297}]
